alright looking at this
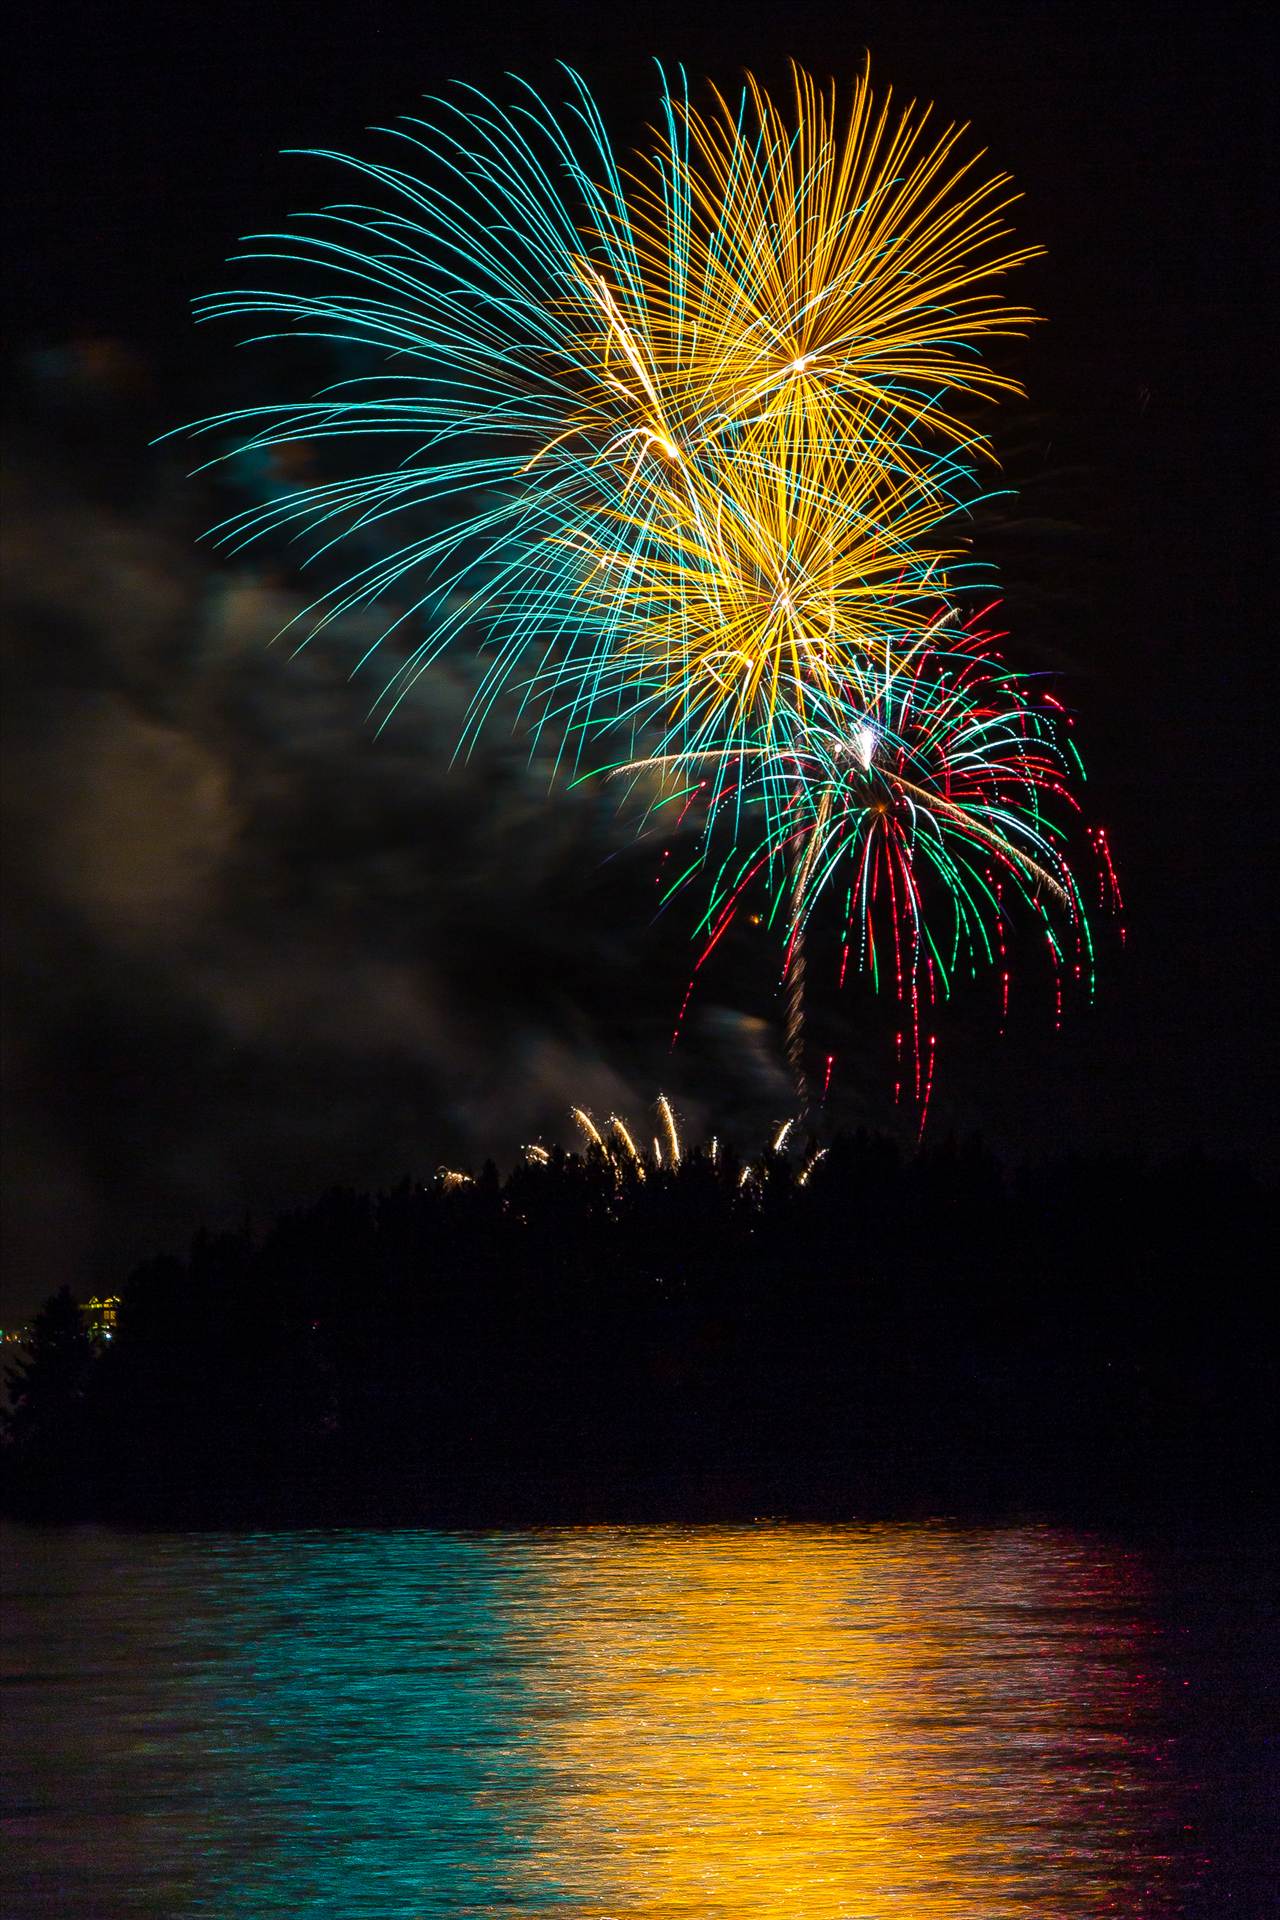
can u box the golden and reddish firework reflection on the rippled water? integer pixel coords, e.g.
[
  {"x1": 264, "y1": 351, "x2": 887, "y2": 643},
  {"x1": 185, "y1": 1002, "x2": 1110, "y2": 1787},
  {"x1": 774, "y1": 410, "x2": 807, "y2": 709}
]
[{"x1": 524, "y1": 1528, "x2": 1157, "y2": 1920}]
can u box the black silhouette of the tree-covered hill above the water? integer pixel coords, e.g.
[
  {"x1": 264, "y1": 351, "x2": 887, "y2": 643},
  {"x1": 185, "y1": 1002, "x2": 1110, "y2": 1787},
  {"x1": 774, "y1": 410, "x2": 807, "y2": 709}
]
[{"x1": 4, "y1": 1135, "x2": 1280, "y2": 1524}]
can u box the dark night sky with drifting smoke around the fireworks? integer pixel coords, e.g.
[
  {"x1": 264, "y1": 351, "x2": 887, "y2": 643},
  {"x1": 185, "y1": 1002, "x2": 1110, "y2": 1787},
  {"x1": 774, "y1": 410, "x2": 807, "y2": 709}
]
[{"x1": 4, "y1": 0, "x2": 1276, "y2": 1311}]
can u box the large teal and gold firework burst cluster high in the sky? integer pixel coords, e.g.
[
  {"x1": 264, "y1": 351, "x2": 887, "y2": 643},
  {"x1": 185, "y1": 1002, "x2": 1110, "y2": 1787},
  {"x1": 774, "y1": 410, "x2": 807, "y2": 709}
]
[{"x1": 185, "y1": 61, "x2": 1031, "y2": 751}]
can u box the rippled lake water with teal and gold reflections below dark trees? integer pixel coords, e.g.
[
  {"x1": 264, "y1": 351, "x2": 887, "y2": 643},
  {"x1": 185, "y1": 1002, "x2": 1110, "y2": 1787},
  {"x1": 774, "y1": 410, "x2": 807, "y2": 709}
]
[{"x1": 0, "y1": 1526, "x2": 1280, "y2": 1920}]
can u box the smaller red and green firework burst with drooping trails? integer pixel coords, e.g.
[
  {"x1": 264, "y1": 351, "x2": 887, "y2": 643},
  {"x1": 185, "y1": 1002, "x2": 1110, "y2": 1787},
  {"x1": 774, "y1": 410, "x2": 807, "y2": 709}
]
[{"x1": 614, "y1": 611, "x2": 1113, "y2": 1125}]
